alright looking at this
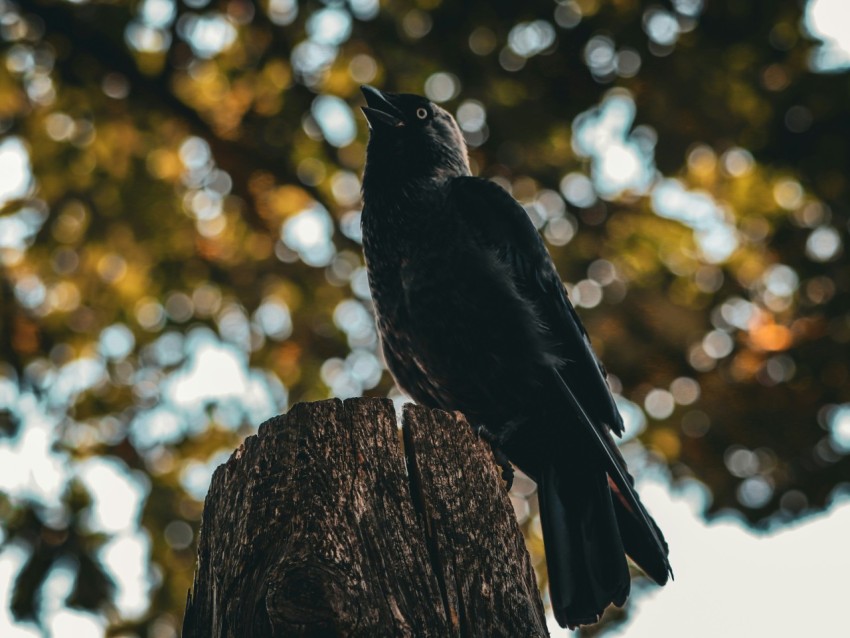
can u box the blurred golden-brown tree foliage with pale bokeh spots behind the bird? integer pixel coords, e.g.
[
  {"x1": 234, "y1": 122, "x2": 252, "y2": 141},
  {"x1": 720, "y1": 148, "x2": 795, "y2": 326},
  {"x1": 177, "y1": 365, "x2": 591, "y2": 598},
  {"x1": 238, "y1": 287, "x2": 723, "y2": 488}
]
[{"x1": 0, "y1": 0, "x2": 850, "y2": 637}]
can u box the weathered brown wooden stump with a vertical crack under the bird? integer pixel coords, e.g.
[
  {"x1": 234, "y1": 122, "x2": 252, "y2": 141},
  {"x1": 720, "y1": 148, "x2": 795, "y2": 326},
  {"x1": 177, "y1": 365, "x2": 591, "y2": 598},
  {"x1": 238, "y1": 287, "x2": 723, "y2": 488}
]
[{"x1": 183, "y1": 399, "x2": 548, "y2": 638}]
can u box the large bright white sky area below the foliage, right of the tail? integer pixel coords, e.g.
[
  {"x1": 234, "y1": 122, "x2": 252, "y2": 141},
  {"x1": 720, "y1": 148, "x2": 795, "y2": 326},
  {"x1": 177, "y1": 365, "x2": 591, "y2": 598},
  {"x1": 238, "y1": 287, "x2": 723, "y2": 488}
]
[{"x1": 549, "y1": 478, "x2": 850, "y2": 638}]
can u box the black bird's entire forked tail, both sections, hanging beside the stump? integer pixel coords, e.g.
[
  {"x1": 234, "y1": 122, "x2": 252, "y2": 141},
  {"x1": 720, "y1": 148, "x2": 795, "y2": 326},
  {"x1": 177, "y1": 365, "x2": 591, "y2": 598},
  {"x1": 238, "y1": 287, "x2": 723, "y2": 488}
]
[{"x1": 538, "y1": 372, "x2": 671, "y2": 627}]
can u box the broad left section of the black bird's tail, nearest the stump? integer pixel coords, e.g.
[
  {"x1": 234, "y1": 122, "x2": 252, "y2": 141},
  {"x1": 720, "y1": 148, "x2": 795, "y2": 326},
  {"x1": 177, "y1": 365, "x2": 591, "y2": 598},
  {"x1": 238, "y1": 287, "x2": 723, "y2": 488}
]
[{"x1": 539, "y1": 463, "x2": 631, "y2": 628}]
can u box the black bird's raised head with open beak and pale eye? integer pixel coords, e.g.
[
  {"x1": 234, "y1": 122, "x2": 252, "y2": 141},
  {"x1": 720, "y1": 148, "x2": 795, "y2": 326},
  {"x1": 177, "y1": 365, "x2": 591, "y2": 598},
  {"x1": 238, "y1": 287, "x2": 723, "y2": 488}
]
[{"x1": 360, "y1": 86, "x2": 469, "y2": 188}]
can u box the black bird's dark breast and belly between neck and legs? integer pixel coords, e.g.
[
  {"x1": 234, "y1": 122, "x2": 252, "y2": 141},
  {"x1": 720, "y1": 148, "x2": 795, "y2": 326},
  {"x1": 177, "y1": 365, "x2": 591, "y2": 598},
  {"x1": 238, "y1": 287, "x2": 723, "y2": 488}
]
[{"x1": 363, "y1": 192, "x2": 544, "y2": 421}]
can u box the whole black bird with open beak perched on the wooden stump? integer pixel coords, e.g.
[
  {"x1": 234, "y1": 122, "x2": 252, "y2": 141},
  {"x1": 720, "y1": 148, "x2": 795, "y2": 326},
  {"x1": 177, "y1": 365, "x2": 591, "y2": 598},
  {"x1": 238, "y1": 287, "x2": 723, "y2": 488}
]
[{"x1": 361, "y1": 86, "x2": 671, "y2": 627}]
